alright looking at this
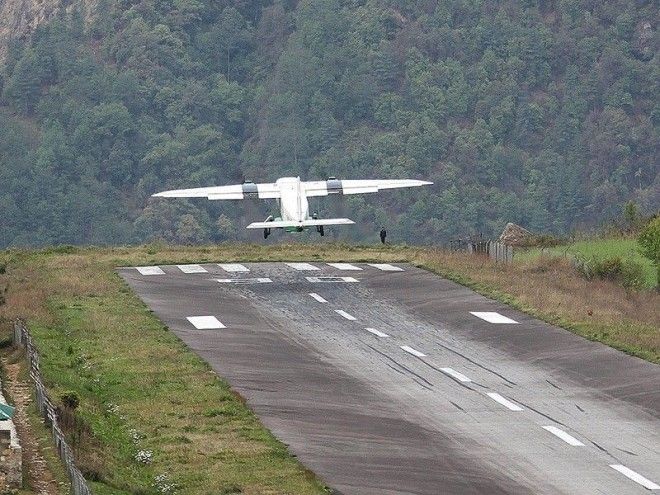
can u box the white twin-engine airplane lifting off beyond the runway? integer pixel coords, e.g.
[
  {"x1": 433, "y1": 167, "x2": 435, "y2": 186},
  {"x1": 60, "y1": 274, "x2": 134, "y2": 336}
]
[{"x1": 152, "y1": 177, "x2": 433, "y2": 239}]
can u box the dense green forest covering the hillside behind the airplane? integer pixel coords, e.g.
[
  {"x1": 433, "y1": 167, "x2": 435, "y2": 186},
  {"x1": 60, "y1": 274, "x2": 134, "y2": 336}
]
[{"x1": 0, "y1": 0, "x2": 660, "y2": 247}]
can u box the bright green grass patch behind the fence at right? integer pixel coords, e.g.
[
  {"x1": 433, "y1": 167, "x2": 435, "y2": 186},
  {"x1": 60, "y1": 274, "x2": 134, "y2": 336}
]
[{"x1": 517, "y1": 237, "x2": 658, "y2": 289}]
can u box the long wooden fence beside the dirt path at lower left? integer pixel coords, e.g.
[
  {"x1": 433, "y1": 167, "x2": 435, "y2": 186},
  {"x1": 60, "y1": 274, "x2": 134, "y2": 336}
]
[{"x1": 14, "y1": 320, "x2": 92, "y2": 495}]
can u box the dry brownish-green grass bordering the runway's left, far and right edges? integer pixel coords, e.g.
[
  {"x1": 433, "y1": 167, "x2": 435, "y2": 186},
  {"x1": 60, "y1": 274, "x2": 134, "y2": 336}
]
[{"x1": 0, "y1": 244, "x2": 660, "y2": 494}]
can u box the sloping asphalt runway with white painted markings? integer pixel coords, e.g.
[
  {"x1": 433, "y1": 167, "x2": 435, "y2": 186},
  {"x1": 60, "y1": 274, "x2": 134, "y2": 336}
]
[{"x1": 119, "y1": 262, "x2": 660, "y2": 495}]
